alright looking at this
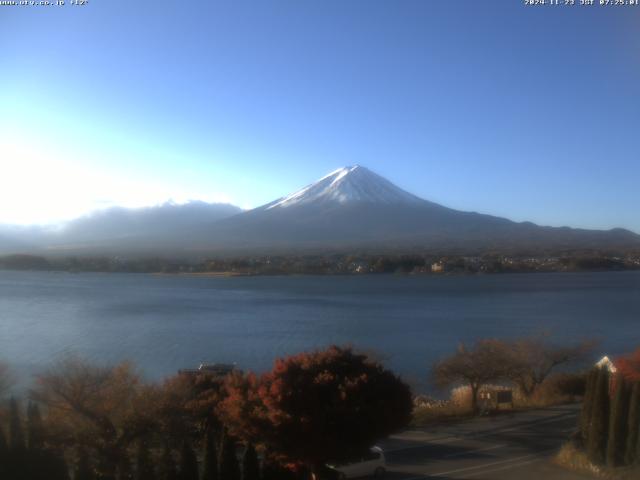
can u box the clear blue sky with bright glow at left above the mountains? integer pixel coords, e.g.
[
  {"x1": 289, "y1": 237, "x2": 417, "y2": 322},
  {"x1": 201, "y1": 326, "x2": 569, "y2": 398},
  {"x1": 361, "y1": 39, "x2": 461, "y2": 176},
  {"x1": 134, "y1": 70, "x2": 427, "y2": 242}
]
[{"x1": 0, "y1": 0, "x2": 640, "y2": 232}]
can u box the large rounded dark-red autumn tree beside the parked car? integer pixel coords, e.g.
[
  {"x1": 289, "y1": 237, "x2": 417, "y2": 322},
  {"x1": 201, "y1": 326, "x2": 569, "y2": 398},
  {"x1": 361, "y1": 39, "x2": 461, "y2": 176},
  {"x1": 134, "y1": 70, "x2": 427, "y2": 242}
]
[{"x1": 221, "y1": 346, "x2": 412, "y2": 472}]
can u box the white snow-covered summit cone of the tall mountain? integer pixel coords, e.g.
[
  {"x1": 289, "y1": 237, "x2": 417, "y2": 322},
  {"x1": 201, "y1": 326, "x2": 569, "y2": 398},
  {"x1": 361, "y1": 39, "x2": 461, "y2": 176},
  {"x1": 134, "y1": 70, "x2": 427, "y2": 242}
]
[{"x1": 262, "y1": 165, "x2": 424, "y2": 210}]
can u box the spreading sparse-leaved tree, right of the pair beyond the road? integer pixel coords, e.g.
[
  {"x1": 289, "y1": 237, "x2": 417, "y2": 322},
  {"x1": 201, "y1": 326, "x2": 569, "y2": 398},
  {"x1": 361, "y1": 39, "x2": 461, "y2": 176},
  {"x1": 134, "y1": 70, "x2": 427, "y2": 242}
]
[{"x1": 500, "y1": 335, "x2": 595, "y2": 397}]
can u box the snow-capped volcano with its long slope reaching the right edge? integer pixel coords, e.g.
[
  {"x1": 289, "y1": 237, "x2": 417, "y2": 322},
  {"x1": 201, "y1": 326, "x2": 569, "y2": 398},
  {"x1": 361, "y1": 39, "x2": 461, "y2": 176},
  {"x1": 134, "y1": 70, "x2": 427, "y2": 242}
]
[{"x1": 198, "y1": 165, "x2": 640, "y2": 251}]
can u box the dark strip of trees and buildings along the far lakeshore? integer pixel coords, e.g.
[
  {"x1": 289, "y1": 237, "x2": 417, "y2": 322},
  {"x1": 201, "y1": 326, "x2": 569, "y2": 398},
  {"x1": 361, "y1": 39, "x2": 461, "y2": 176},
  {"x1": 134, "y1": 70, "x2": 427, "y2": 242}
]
[{"x1": 0, "y1": 251, "x2": 640, "y2": 276}]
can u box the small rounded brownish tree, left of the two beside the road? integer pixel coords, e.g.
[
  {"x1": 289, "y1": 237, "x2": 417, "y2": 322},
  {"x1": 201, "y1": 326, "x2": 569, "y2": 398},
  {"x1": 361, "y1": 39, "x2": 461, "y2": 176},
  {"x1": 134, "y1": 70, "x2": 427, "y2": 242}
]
[{"x1": 433, "y1": 340, "x2": 508, "y2": 412}]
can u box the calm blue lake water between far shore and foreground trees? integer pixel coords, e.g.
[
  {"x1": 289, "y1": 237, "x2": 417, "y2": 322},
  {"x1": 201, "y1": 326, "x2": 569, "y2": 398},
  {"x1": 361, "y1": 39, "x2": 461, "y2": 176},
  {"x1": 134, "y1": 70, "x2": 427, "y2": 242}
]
[{"x1": 0, "y1": 271, "x2": 640, "y2": 390}]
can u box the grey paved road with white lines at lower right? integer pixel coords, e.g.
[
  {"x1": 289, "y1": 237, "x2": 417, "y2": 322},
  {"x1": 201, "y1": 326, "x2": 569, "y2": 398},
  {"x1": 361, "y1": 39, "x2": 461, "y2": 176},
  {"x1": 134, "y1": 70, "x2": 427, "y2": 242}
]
[{"x1": 381, "y1": 405, "x2": 592, "y2": 480}]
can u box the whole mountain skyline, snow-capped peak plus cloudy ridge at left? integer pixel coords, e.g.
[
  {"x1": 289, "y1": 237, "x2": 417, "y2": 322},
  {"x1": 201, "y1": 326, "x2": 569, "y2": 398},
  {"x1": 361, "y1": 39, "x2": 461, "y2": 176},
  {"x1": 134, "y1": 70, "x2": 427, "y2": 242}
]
[{"x1": 0, "y1": 165, "x2": 640, "y2": 255}]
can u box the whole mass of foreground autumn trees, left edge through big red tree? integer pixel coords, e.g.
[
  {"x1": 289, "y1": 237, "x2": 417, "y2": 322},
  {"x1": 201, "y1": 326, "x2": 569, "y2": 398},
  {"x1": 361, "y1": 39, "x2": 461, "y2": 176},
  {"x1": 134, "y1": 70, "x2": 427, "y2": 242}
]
[{"x1": 0, "y1": 347, "x2": 412, "y2": 480}]
